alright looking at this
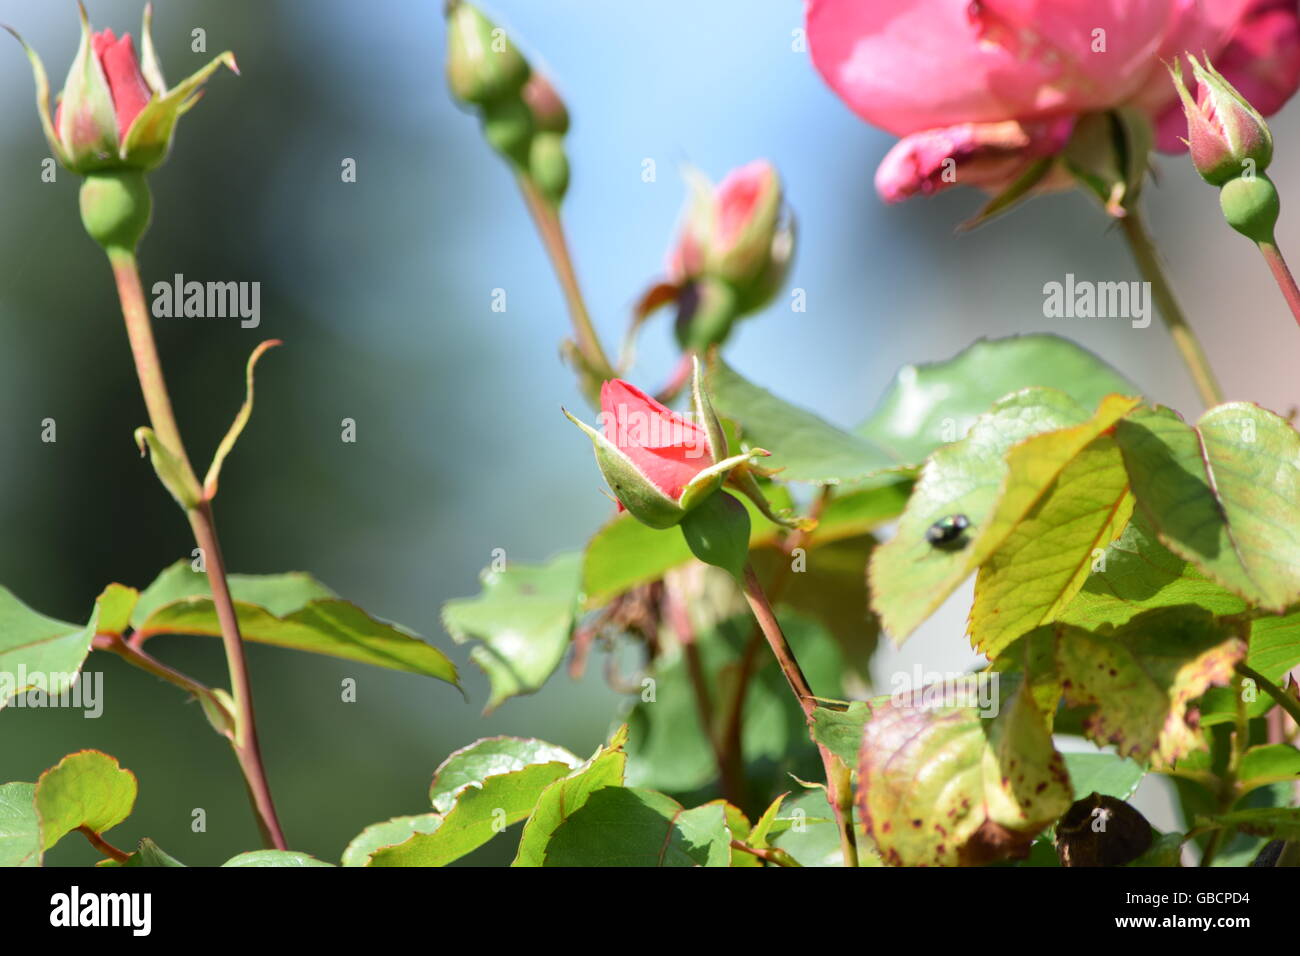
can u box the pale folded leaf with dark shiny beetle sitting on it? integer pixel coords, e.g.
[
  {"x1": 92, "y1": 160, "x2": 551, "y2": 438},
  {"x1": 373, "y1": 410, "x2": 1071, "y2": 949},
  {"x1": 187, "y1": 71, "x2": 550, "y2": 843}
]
[{"x1": 870, "y1": 389, "x2": 1136, "y2": 641}]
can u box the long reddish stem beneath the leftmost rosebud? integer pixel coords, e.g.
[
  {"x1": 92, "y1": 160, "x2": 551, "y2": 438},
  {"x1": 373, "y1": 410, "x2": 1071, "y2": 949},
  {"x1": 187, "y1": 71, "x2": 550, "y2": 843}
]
[{"x1": 108, "y1": 248, "x2": 287, "y2": 849}]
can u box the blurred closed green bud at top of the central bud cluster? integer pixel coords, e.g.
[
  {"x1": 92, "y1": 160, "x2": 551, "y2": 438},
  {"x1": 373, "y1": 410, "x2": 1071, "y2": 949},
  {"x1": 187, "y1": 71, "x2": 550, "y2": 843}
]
[{"x1": 447, "y1": 0, "x2": 530, "y2": 107}]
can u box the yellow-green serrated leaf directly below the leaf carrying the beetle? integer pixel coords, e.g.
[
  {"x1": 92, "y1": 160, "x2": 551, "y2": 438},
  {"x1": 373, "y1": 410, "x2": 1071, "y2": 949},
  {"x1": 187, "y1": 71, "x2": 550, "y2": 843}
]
[{"x1": 970, "y1": 434, "x2": 1134, "y2": 657}]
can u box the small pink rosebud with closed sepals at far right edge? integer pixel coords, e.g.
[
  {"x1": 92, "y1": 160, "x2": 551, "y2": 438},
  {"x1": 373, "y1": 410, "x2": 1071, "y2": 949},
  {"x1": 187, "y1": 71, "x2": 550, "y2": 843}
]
[{"x1": 1169, "y1": 53, "x2": 1273, "y2": 186}]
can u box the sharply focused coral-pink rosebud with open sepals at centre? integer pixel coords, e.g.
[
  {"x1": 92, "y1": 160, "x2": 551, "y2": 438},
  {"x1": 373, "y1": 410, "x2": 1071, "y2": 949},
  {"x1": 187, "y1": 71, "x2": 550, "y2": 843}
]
[{"x1": 564, "y1": 360, "x2": 767, "y2": 528}]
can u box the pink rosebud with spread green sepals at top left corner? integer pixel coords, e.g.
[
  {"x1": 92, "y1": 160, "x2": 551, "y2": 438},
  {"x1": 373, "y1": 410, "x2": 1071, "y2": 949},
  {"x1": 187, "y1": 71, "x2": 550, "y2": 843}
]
[{"x1": 10, "y1": 5, "x2": 238, "y2": 174}]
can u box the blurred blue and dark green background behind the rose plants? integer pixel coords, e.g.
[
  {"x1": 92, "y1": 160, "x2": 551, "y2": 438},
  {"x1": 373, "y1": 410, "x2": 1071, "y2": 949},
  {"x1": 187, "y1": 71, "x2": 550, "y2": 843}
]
[{"x1": 0, "y1": 0, "x2": 1300, "y2": 864}]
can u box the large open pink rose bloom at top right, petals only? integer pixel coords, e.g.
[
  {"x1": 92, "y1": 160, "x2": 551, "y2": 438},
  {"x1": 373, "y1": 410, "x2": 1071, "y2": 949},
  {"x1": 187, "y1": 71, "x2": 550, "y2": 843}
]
[{"x1": 807, "y1": 0, "x2": 1300, "y2": 202}]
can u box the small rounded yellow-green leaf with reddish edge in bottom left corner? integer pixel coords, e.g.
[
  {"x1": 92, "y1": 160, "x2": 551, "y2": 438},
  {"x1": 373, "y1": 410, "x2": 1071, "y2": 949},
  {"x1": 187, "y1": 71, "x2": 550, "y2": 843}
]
[{"x1": 34, "y1": 750, "x2": 137, "y2": 849}]
